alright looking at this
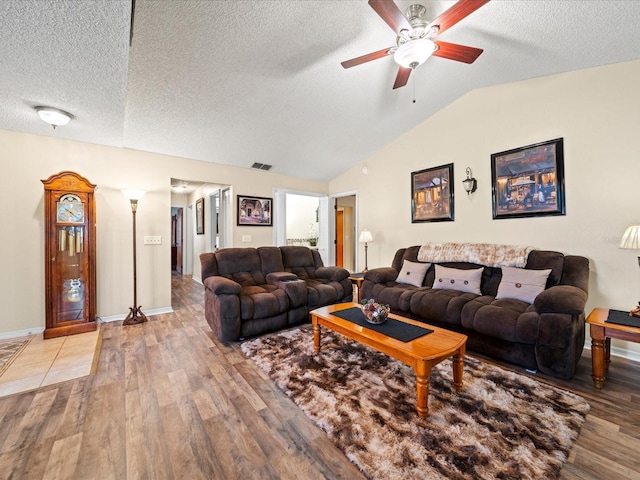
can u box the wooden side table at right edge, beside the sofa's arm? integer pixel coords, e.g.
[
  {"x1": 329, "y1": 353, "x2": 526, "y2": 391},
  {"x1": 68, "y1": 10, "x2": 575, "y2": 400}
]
[{"x1": 586, "y1": 308, "x2": 640, "y2": 388}]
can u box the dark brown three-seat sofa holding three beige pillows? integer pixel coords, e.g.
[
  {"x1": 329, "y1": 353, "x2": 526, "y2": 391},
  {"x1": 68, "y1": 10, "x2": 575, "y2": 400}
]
[{"x1": 362, "y1": 246, "x2": 589, "y2": 378}]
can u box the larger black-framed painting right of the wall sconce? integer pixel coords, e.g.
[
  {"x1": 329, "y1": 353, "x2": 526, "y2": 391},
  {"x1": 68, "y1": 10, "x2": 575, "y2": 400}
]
[{"x1": 491, "y1": 138, "x2": 565, "y2": 219}]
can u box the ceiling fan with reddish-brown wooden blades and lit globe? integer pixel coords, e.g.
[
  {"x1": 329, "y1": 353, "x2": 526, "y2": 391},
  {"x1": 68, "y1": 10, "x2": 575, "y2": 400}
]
[{"x1": 341, "y1": 0, "x2": 489, "y2": 89}]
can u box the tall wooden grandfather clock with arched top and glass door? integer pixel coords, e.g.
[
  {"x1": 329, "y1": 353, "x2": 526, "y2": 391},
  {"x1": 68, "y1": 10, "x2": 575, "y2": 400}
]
[{"x1": 42, "y1": 172, "x2": 96, "y2": 338}]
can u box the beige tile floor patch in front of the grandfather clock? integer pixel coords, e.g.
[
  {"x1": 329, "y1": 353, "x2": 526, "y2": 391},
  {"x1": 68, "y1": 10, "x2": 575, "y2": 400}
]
[{"x1": 0, "y1": 325, "x2": 101, "y2": 397}]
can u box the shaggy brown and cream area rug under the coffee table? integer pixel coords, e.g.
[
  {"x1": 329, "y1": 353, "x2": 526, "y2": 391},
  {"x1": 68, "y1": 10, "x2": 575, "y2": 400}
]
[{"x1": 241, "y1": 325, "x2": 589, "y2": 479}]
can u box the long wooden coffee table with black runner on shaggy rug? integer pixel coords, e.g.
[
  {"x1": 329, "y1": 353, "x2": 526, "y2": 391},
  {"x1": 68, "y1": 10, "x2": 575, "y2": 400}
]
[{"x1": 311, "y1": 303, "x2": 467, "y2": 418}]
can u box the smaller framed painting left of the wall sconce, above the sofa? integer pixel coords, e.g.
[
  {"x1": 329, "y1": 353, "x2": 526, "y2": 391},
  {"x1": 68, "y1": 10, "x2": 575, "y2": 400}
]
[{"x1": 411, "y1": 163, "x2": 453, "y2": 223}]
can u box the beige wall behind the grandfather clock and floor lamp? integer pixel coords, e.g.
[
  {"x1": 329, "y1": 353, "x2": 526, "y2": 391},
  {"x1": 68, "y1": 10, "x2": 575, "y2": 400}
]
[{"x1": 0, "y1": 130, "x2": 327, "y2": 336}]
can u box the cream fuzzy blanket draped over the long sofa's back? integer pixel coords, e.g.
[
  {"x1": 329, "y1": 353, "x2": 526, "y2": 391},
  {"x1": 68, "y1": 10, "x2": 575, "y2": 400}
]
[{"x1": 418, "y1": 242, "x2": 534, "y2": 268}]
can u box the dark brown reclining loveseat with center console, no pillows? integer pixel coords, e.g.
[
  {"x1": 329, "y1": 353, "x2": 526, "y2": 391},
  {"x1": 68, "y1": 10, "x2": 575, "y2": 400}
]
[{"x1": 200, "y1": 246, "x2": 353, "y2": 341}]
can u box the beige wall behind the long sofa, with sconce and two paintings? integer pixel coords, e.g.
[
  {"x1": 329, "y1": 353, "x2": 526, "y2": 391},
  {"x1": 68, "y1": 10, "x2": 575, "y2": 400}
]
[{"x1": 330, "y1": 61, "x2": 640, "y2": 356}]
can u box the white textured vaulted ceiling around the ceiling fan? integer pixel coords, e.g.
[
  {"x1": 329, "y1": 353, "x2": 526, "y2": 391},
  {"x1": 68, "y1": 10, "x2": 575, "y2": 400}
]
[{"x1": 0, "y1": 0, "x2": 640, "y2": 180}]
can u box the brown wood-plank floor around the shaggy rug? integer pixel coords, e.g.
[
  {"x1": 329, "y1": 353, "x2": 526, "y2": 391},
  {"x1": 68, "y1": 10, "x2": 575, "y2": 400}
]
[{"x1": 0, "y1": 277, "x2": 640, "y2": 480}]
